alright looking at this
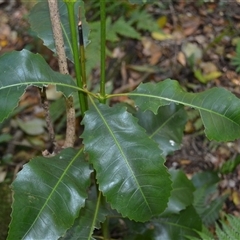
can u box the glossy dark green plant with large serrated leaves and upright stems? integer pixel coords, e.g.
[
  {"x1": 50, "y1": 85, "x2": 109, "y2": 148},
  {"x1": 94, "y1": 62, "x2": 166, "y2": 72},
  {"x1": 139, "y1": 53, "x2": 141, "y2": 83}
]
[{"x1": 0, "y1": 0, "x2": 240, "y2": 240}]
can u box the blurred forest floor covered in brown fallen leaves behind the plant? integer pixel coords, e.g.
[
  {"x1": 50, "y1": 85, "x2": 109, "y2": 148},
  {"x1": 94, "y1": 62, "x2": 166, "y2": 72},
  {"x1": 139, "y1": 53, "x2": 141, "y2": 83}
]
[{"x1": 0, "y1": 0, "x2": 240, "y2": 239}]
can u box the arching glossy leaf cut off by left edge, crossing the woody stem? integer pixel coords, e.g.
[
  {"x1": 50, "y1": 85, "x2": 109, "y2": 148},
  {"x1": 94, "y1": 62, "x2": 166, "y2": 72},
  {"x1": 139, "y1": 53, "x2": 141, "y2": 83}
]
[{"x1": 0, "y1": 50, "x2": 77, "y2": 122}]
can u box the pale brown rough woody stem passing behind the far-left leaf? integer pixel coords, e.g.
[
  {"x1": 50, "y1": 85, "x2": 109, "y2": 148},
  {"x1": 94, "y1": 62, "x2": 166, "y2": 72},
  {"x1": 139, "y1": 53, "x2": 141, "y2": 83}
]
[{"x1": 48, "y1": 0, "x2": 75, "y2": 148}]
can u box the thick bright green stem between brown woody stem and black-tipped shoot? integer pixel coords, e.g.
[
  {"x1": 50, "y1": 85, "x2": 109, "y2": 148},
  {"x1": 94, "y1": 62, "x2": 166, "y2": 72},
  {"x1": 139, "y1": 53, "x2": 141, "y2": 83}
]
[{"x1": 64, "y1": 0, "x2": 88, "y2": 115}]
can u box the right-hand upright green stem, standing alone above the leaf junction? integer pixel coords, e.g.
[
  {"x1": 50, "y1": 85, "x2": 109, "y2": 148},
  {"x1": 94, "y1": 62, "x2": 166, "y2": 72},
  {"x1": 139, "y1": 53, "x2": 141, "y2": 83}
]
[{"x1": 100, "y1": 0, "x2": 106, "y2": 103}]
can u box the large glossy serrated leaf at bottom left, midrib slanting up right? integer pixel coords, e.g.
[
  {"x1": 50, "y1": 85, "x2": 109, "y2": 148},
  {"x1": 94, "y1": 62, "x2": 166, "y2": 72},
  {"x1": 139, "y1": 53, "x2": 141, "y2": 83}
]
[{"x1": 8, "y1": 148, "x2": 91, "y2": 240}]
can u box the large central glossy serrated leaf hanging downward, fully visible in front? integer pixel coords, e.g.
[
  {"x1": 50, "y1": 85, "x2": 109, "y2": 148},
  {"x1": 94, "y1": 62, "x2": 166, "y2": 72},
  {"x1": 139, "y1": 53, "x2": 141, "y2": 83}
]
[{"x1": 82, "y1": 101, "x2": 171, "y2": 221}]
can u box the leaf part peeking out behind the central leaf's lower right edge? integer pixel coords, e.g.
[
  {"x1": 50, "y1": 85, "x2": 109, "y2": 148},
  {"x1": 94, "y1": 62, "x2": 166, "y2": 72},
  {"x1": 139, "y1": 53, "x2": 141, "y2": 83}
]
[{"x1": 161, "y1": 169, "x2": 195, "y2": 216}]
